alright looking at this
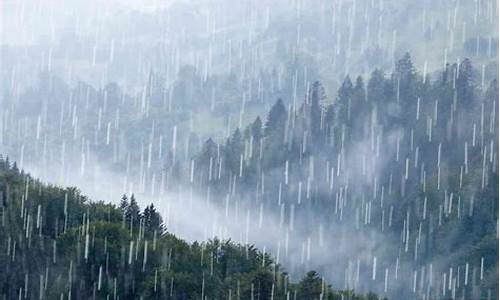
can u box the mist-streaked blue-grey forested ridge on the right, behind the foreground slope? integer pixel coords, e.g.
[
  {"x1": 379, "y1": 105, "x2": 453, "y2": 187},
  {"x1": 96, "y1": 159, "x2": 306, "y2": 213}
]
[{"x1": 158, "y1": 54, "x2": 498, "y2": 299}]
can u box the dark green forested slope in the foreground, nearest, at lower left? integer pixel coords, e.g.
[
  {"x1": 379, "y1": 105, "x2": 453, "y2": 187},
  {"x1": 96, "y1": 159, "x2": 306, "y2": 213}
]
[{"x1": 0, "y1": 158, "x2": 379, "y2": 300}]
